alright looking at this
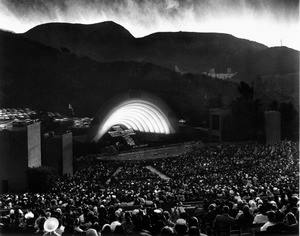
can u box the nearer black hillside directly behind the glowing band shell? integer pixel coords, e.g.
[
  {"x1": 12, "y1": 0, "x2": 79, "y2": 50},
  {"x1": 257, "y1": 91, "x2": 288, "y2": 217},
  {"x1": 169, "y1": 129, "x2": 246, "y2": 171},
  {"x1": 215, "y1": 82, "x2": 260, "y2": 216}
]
[{"x1": 0, "y1": 31, "x2": 237, "y2": 121}]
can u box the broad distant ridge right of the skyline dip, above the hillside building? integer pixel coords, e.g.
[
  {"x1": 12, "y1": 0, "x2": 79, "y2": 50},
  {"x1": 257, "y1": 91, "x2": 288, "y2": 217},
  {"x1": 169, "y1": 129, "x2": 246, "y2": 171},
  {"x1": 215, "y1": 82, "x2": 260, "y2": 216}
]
[{"x1": 138, "y1": 32, "x2": 267, "y2": 73}]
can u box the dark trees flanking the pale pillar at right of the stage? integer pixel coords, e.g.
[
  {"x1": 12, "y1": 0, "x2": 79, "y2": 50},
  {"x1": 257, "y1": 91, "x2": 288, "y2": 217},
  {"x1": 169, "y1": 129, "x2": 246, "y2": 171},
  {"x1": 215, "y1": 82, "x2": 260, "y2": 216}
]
[{"x1": 223, "y1": 82, "x2": 299, "y2": 142}]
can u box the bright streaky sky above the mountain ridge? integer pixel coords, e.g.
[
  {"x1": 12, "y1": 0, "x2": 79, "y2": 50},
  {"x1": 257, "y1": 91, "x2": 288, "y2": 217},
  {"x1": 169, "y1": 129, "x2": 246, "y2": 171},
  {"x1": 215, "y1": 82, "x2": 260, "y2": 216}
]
[{"x1": 0, "y1": 0, "x2": 300, "y2": 50}]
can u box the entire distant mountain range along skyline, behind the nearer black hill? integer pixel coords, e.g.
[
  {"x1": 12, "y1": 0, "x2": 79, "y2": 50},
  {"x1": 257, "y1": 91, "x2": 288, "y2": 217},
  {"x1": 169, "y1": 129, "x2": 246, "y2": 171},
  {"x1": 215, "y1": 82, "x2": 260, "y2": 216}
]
[{"x1": 23, "y1": 22, "x2": 299, "y2": 107}]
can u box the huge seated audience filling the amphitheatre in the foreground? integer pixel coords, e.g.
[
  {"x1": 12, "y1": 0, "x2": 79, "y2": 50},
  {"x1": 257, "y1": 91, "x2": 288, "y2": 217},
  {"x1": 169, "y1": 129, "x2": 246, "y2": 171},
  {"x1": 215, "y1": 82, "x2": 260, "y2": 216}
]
[{"x1": 0, "y1": 141, "x2": 299, "y2": 235}]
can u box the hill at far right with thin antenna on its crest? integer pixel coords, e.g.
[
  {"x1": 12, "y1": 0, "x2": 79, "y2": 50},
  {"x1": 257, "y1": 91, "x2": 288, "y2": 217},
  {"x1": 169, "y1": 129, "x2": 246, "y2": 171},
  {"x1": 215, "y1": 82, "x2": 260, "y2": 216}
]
[{"x1": 232, "y1": 47, "x2": 299, "y2": 108}]
